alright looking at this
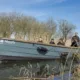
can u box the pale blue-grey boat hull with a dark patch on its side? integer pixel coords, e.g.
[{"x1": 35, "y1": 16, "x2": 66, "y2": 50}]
[{"x1": 0, "y1": 39, "x2": 80, "y2": 60}]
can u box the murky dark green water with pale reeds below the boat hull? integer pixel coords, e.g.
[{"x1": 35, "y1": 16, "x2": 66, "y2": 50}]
[{"x1": 0, "y1": 60, "x2": 78, "y2": 80}]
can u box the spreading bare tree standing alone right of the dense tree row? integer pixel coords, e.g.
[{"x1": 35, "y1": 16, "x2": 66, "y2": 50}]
[{"x1": 59, "y1": 20, "x2": 76, "y2": 42}]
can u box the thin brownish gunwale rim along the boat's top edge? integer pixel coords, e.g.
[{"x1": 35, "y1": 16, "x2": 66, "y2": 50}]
[{"x1": 0, "y1": 38, "x2": 80, "y2": 49}]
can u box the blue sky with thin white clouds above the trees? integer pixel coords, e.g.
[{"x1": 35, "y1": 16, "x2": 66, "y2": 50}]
[{"x1": 0, "y1": 0, "x2": 80, "y2": 35}]
